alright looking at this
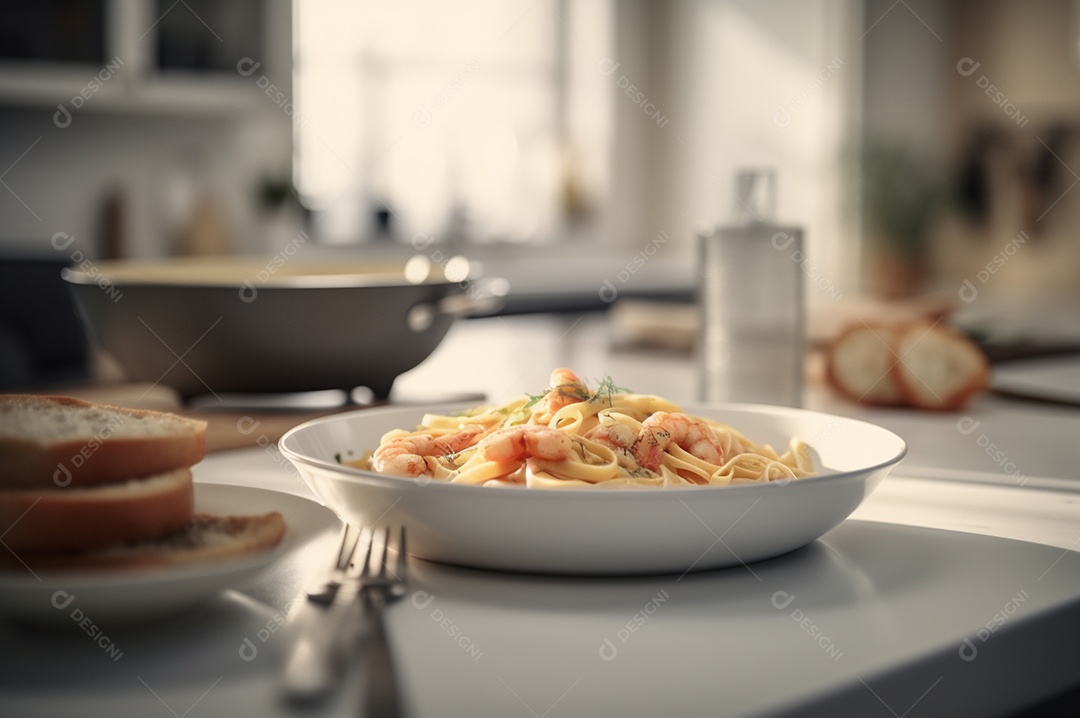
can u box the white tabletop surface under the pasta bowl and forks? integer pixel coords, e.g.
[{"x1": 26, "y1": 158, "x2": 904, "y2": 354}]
[{"x1": 0, "y1": 315, "x2": 1080, "y2": 718}]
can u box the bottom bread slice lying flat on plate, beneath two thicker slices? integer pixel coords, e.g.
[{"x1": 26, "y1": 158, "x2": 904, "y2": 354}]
[{"x1": 7, "y1": 512, "x2": 285, "y2": 572}]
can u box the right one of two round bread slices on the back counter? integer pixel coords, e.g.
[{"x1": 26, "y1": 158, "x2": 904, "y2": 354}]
[{"x1": 893, "y1": 323, "x2": 990, "y2": 411}]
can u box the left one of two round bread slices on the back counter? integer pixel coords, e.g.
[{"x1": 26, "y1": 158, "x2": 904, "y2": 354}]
[{"x1": 825, "y1": 324, "x2": 904, "y2": 406}]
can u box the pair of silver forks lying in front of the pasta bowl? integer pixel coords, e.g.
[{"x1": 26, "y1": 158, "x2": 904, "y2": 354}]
[{"x1": 282, "y1": 526, "x2": 406, "y2": 703}]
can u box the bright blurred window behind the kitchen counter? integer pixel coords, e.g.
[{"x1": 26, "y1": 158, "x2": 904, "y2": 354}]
[{"x1": 294, "y1": 0, "x2": 612, "y2": 243}]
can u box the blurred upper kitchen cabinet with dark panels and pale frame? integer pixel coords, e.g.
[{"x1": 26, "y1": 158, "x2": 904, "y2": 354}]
[{"x1": 0, "y1": 0, "x2": 292, "y2": 116}]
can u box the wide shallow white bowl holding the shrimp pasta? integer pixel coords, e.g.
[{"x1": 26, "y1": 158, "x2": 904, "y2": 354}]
[{"x1": 280, "y1": 405, "x2": 906, "y2": 574}]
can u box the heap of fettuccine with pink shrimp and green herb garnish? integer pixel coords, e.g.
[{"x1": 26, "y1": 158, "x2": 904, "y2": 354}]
[{"x1": 348, "y1": 369, "x2": 814, "y2": 488}]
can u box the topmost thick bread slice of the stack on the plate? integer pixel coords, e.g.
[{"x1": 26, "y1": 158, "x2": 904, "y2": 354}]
[{"x1": 0, "y1": 394, "x2": 206, "y2": 489}]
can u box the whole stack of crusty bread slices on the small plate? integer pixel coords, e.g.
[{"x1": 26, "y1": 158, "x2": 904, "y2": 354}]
[{"x1": 0, "y1": 394, "x2": 285, "y2": 575}]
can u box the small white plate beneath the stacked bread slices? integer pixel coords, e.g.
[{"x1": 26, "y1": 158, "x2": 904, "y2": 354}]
[{"x1": 0, "y1": 483, "x2": 340, "y2": 624}]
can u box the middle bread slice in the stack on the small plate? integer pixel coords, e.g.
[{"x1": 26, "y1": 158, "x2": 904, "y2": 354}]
[{"x1": 0, "y1": 469, "x2": 194, "y2": 560}]
